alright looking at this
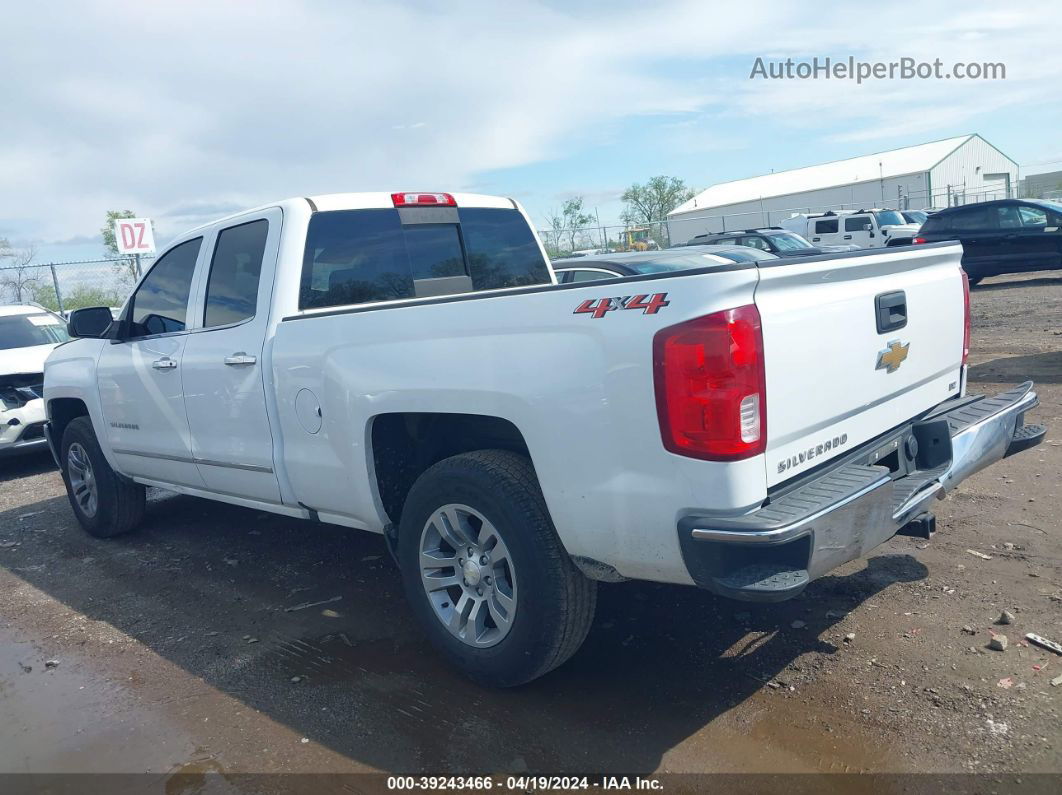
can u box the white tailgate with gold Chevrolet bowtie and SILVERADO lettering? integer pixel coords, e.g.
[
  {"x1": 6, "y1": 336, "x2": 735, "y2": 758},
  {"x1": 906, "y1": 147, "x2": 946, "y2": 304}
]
[{"x1": 755, "y1": 244, "x2": 964, "y2": 486}]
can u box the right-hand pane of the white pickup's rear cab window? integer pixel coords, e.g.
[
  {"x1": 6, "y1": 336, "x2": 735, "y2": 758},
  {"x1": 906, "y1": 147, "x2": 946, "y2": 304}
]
[{"x1": 460, "y1": 208, "x2": 549, "y2": 290}]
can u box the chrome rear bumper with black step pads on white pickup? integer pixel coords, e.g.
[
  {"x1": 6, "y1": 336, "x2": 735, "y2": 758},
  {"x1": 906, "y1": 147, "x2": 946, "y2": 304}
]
[{"x1": 679, "y1": 381, "x2": 1046, "y2": 601}]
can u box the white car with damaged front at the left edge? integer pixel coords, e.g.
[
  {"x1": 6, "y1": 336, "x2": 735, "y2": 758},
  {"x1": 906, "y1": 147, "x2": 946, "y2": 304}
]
[{"x1": 0, "y1": 305, "x2": 69, "y2": 455}]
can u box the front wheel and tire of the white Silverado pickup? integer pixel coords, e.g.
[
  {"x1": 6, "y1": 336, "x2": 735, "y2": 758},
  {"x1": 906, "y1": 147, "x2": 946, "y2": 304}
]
[{"x1": 59, "y1": 417, "x2": 147, "y2": 538}]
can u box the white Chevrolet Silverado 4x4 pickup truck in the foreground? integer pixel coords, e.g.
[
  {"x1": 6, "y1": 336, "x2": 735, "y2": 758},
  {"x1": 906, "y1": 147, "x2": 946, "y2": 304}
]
[{"x1": 45, "y1": 193, "x2": 1044, "y2": 686}]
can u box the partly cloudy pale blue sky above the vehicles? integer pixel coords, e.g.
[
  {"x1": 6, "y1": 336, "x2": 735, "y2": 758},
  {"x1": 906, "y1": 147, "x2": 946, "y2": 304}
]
[{"x1": 0, "y1": 0, "x2": 1062, "y2": 262}]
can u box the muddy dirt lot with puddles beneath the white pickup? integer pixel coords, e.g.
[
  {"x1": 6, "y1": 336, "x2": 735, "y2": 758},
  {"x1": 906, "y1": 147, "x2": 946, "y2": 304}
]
[{"x1": 0, "y1": 273, "x2": 1062, "y2": 774}]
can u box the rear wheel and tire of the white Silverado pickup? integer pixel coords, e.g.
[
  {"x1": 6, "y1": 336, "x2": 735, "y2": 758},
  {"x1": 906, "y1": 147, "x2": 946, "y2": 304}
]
[{"x1": 398, "y1": 450, "x2": 597, "y2": 688}]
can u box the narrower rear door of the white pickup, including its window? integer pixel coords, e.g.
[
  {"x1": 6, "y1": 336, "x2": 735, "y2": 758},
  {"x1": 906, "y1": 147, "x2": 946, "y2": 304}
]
[{"x1": 183, "y1": 209, "x2": 282, "y2": 503}]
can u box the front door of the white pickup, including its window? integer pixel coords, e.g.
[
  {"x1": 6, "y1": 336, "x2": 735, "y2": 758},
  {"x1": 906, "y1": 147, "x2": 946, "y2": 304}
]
[{"x1": 97, "y1": 238, "x2": 203, "y2": 487}]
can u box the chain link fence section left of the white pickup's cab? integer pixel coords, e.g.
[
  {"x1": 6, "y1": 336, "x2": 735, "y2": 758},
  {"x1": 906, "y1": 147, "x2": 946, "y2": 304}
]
[{"x1": 0, "y1": 257, "x2": 153, "y2": 313}]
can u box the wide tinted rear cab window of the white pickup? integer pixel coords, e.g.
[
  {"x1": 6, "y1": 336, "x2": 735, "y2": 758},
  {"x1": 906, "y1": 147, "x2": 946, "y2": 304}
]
[{"x1": 298, "y1": 207, "x2": 550, "y2": 309}]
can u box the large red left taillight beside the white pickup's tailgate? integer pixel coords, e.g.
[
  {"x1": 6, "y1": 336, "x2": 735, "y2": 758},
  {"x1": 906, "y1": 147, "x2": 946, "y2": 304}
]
[{"x1": 653, "y1": 304, "x2": 767, "y2": 461}]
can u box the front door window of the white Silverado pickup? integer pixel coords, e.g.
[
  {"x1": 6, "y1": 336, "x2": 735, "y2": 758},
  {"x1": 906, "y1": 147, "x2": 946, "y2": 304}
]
[{"x1": 130, "y1": 238, "x2": 203, "y2": 336}]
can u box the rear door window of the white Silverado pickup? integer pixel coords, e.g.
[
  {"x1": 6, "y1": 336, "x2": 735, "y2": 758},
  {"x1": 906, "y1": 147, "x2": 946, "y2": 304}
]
[{"x1": 203, "y1": 219, "x2": 269, "y2": 328}]
